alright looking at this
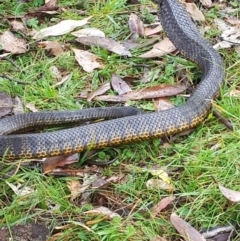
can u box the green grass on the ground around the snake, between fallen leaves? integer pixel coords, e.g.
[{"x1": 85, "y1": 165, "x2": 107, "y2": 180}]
[{"x1": 0, "y1": 0, "x2": 240, "y2": 241}]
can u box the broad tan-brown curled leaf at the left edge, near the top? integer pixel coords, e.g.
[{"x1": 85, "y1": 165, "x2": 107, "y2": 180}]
[{"x1": 0, "y1": 30, "x2": 28, "y2": 54}]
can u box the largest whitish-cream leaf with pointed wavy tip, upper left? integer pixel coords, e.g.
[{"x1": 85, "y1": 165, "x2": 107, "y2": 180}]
[{"x1": 33, "y1": 17, "x2": 92, "y2": 39}]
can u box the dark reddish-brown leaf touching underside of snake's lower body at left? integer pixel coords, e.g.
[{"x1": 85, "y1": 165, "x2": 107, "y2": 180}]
[{"x1": 42, "y1": 154, "x2": 78, "y2": 174}]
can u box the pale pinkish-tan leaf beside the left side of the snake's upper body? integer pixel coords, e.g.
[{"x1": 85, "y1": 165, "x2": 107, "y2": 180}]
[{"x1": 139, "y1": 38, "x2": 176, "y2": 58}]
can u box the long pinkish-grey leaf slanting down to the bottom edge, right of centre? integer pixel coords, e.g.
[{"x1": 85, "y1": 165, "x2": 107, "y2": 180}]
[{"x1": 170, "y1": 213, "x2": 206, "y2": 241}]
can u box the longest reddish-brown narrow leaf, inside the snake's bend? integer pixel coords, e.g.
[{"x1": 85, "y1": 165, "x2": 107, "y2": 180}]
[{"x1": 95, "y1": 85, "x2": 187, "y2": 102}]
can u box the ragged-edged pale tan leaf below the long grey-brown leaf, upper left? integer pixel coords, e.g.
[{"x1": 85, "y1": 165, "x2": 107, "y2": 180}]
[{"x1": 72, "y1": 49, "x2": 103, "y2": 73}]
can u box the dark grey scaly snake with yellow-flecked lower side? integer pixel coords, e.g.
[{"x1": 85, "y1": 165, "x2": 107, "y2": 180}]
[{"x1": 0, "y1": 0, "x2": 224, "y2": 160}]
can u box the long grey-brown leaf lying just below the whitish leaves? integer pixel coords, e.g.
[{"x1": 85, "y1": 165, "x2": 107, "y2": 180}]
[{"x1": 76, "y1": 36, "x2": 132, "y2": 57}]
